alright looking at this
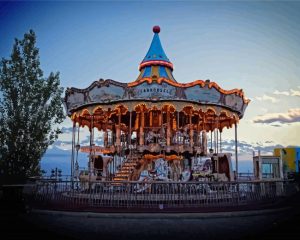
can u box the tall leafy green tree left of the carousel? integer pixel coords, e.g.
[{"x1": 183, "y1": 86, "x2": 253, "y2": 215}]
[{"x1": 0, "y1": 30, "x2": 64, "y2": 182}]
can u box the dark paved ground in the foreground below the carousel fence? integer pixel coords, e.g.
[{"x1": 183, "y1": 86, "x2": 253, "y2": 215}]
[{"x1": 1, "y1": 205, "x2": 300, "y2": 240}]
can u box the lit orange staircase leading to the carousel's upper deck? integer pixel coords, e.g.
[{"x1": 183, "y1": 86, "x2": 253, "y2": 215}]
[{"x1": 113, "y1": 154, "x2": 139, "y2": 182}]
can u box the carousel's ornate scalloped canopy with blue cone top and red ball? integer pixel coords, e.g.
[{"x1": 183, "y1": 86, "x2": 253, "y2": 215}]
[{"x1": 64, "y1": 26, "x2": 250, "y2": 131}]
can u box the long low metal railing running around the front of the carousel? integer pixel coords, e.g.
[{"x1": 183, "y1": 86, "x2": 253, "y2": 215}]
[{"x1": 20, "y1": 181, "x2": 298, "y2": 210}]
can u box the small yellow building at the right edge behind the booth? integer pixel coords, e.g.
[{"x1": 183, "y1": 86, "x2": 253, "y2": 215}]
[{"x1": 274, "y1": 147, "x2": 300, "y2": 173}]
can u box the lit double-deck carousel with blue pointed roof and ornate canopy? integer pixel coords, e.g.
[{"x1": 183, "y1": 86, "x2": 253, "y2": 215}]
[{"x1": 64, "y1": 26, "x2": 249, "y2": 182}]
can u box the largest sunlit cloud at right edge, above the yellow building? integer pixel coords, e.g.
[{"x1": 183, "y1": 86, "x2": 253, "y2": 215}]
[{"x1": 253, "y1": 108, "x2": 300, "y2": 124}]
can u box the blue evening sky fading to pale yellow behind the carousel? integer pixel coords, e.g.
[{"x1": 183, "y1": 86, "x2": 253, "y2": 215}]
[{"x1": 0, "y1": 1, "x2": 300, "y2": 160}]
